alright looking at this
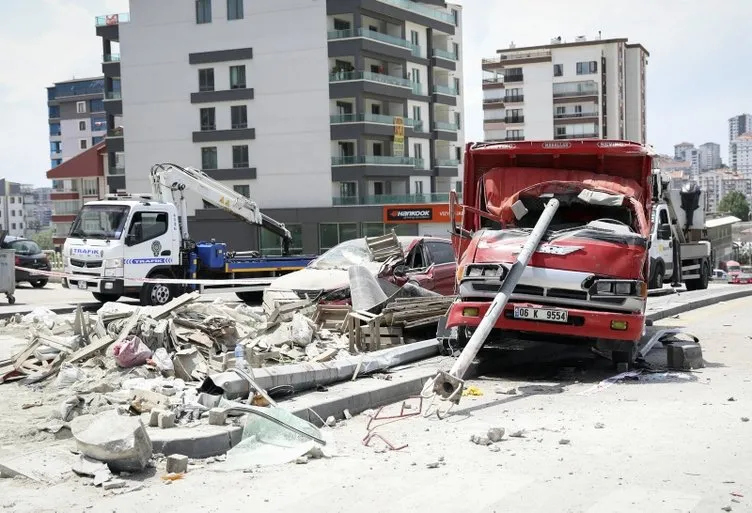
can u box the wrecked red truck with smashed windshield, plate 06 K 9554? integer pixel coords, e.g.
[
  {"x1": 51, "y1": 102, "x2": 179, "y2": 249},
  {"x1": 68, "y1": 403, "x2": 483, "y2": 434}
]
[{"x1": 446, "y1": 140, "x2": 653, "y2": 364}]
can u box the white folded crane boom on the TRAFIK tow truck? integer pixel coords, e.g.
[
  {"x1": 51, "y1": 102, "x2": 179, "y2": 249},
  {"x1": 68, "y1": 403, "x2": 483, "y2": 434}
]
[{"x1": 151, "y1": 163, "x2": 292, "y2": 255}]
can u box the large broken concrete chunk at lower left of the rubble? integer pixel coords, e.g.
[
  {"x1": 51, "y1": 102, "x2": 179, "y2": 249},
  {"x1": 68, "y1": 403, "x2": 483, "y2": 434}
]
[{"x1": 71, "y1": 411, "x2": 152, "y2": 472}]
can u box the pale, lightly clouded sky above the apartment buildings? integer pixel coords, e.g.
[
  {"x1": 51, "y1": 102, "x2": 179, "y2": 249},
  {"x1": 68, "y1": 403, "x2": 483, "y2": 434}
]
[{"x1": 0, "y1": 0, "x2": 752, "y2": 185}]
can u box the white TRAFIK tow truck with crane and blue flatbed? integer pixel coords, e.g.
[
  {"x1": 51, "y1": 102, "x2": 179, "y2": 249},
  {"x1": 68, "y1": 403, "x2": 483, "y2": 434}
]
[{"x1": 63, "y1": 163, "x2": 315, "y2": 305}]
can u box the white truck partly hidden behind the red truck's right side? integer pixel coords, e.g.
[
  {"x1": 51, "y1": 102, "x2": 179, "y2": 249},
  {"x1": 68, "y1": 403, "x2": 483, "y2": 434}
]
[{"x1": 649, "y1": 170, "x2": 713, "y2": 290}]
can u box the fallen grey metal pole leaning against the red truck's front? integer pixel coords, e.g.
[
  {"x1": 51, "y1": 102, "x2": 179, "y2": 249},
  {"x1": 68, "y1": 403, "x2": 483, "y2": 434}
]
[{"x1": 434, "y1": 198, "x2": 559, "y2": 403}]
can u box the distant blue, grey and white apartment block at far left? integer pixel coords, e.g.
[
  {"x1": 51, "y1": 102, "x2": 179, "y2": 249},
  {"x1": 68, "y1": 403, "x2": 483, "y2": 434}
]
[{"x1": 47, "y1": 77, "x2": 107, "y2": 168}]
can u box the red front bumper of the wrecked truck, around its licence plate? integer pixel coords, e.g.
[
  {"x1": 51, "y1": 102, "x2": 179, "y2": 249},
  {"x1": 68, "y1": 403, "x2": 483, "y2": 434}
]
[{"x1": 446, "y1": 300, "x2": 645, "y2": 343}]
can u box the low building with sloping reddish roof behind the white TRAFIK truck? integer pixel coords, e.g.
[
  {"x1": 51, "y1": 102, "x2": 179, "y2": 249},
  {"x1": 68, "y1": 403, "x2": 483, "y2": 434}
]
[{"x1": 47, "y1": 141, "x2": 108, "y2": 246}]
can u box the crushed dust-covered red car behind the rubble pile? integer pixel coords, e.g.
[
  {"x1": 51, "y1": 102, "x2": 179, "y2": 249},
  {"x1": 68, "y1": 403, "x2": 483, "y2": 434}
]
[{"x1": 268, "y1": 236, "x2": 457, "y2": 301}]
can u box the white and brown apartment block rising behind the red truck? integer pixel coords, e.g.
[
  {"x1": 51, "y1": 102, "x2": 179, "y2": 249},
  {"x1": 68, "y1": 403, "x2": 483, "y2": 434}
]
[{"x1": 482, "y1": 35, "x2": 649, "y2": 143}]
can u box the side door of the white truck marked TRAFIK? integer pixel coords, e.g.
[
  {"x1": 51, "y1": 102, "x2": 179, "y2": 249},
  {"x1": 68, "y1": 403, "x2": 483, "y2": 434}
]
[{"x1": 123, "y1": 210, "x2": 179, "y2": 278}]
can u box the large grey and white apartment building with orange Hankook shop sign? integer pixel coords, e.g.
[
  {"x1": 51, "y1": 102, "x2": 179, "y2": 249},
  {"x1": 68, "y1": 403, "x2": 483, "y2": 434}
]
[{"x1": 97, "y1": 0, "x2": 464, "y2": 253}]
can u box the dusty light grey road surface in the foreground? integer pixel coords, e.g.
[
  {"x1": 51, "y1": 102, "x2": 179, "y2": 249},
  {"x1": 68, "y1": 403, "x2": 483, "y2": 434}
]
[{"x1": 0, "y1": 290, "x2": 752, "y2": 513}]
